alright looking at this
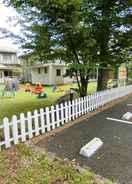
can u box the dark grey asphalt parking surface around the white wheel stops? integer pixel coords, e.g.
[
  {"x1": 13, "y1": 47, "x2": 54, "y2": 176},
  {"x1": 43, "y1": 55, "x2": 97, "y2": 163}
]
[{"x1": 37, "y1": 96, "x2": 132, "y2": 184}]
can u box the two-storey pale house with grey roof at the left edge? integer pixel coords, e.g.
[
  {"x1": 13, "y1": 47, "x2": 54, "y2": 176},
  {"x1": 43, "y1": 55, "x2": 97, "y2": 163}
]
[{"x1": 0, "y1": 47, "x2": 21, "y2": 79}]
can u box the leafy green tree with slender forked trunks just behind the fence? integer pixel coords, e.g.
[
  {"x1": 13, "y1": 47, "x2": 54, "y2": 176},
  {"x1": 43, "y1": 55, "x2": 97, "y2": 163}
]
[{"x1": 3, "y1": 0, "x2": 96, "y2": 96}]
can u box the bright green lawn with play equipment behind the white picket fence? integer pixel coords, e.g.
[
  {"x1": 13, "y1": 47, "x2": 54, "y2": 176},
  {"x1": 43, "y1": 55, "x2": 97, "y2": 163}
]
[{"x1": 0, "y1": 82, "x2": 96, "y2": 123}]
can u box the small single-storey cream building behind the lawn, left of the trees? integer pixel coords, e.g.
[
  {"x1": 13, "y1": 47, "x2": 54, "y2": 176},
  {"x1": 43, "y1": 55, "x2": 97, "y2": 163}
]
[{"x1": 23, "y1": 61, "x2": 73, "y2": 85}]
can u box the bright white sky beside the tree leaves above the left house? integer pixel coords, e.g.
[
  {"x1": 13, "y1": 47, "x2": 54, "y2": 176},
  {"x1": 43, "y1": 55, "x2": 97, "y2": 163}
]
[{"x1": 0, "y1": 0, "x2": 20, "y2": 48}]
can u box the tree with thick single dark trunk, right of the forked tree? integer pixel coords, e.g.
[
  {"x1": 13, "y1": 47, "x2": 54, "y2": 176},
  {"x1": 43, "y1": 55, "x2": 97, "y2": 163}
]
[{"x1": 88, "y1": 0, "x2": 132, "y2": 90}]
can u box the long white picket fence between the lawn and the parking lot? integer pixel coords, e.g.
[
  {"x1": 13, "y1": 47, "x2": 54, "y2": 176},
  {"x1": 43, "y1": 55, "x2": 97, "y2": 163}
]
[{"x1": 0, "y1": 85, "x2": 132, "y2": 148}]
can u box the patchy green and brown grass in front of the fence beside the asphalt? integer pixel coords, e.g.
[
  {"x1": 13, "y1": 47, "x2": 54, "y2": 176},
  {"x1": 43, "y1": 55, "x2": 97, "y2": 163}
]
[{"x1": 0, "y1": 144, "x2": 112, "y2": 184}]
